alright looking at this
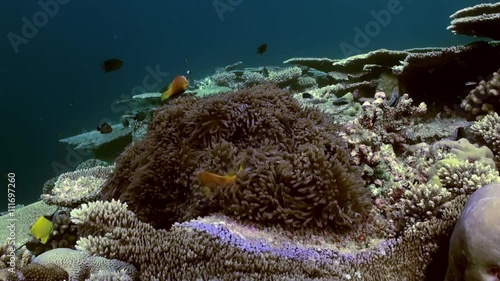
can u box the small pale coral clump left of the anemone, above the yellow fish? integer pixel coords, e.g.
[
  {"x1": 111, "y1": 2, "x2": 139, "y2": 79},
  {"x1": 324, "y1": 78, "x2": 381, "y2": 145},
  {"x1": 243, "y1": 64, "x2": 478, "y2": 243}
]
[{"x1": 41, "y1": 166, "x2": 114, "y2": 208}]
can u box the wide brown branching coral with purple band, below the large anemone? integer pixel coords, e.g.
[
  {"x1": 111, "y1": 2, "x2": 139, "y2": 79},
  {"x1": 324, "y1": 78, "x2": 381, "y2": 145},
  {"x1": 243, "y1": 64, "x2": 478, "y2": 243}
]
[{"x1": 72, "y1": 196, "x2": 465, "y2": 281}]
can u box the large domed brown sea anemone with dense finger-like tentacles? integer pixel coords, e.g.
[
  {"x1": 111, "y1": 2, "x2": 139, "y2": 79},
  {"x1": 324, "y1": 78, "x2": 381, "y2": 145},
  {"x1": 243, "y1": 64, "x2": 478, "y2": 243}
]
[{"x1": 101, "y1": 84, "x2": 371, "y2": 228}]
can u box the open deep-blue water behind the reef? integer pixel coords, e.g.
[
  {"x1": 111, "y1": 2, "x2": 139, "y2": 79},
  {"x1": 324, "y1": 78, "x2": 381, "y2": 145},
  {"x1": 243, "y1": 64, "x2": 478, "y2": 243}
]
[{"x1": 0, "y1": 0, "x2": 495, "y2": 206}]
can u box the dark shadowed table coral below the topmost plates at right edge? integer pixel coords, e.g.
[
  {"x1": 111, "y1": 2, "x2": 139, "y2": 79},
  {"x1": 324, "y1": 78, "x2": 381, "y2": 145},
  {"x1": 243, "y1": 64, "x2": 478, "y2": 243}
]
[{"x1": 393, "y1": 42, "x2": 500, "y2": 108}]
